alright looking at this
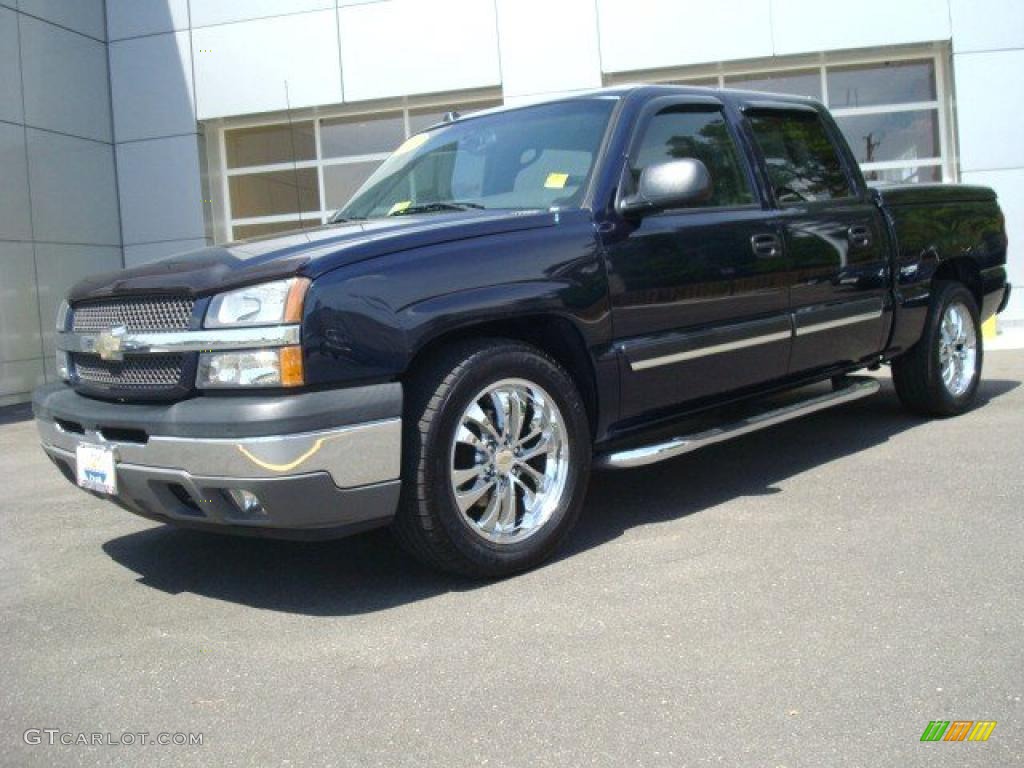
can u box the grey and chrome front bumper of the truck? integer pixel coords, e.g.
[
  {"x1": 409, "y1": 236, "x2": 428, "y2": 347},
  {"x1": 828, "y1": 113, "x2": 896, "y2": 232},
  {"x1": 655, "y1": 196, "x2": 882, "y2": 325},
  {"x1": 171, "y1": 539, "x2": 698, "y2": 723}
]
[{"x1": 33, "y1": 384, "x2": 401, "y2": 538}]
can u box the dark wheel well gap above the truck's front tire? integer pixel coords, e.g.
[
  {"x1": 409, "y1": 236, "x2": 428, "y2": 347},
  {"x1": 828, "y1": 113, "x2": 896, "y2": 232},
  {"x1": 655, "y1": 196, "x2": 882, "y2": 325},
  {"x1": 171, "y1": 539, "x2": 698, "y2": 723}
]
[{"x1": 402, "y1": 315, "x2": 598, "y2": 435}]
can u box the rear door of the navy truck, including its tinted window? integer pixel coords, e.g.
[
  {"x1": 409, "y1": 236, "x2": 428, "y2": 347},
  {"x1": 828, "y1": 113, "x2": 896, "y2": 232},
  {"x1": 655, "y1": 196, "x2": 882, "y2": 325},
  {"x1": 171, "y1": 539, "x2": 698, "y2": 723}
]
[{"x1": 744, "y1": 103, "x2": 889, "y2": 374}]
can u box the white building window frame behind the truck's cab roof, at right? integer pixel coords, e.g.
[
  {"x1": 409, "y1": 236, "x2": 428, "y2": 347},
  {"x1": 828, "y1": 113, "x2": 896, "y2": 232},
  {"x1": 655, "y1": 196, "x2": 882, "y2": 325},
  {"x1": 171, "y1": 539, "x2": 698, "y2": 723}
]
[{"x1": 604, "y1": 42, "x2": 959, "y2": 190}]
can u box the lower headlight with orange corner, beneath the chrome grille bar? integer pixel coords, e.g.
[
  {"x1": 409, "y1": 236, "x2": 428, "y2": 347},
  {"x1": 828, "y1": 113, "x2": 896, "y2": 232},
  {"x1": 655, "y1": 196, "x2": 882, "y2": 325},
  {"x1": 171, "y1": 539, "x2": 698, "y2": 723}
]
[{"x1": 196, "y1": 346, "x2": 303, "y2": 389}]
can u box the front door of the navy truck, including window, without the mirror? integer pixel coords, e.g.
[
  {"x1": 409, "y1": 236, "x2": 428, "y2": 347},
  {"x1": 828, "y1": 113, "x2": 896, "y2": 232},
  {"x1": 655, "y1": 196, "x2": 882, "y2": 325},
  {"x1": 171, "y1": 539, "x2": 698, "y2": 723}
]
[{"x1": 604, "y1": 97, "x2": 792, "y2": 420}]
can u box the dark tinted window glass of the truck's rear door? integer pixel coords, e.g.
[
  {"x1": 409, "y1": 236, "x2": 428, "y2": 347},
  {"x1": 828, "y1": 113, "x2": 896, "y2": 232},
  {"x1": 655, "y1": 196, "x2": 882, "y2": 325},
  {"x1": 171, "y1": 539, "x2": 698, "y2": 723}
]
[{"x1": 751, "y1": 112, "x2": 853, "y2": 203}]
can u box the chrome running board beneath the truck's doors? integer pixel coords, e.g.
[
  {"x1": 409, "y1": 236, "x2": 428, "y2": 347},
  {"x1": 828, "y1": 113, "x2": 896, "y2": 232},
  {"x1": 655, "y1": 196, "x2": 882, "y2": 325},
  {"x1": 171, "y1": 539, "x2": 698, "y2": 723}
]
[{"x1": 594, "y1": 377, "x2": 881, "y2": 469}]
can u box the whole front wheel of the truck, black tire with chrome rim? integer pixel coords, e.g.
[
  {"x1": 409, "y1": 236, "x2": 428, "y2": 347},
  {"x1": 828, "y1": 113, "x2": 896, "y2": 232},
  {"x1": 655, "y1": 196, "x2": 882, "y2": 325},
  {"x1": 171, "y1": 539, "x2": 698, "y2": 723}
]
[{"x1": 392, "y1": 339, "x2": 591, "y2": 579}]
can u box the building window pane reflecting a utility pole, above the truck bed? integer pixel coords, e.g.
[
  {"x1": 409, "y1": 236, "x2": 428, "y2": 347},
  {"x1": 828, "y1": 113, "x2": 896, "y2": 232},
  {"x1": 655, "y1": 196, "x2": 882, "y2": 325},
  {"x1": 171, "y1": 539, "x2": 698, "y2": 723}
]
[{"x1": 836, "y1": 110, "x2": 940, "y2": 163}]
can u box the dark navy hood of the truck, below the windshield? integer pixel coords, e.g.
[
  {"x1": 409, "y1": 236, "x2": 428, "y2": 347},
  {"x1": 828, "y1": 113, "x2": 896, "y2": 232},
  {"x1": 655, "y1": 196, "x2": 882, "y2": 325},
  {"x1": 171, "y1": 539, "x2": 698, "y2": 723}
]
[{"x1": 68, "y1": 211, "x2": 564, "y2": 302}]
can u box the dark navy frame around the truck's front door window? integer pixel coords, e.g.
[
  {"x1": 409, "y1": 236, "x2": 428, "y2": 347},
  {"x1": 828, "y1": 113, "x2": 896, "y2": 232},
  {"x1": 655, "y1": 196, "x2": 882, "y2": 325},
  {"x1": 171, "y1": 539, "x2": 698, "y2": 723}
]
[{"x1": 613, "y1": 94, "x2": 765, "y2": 216}]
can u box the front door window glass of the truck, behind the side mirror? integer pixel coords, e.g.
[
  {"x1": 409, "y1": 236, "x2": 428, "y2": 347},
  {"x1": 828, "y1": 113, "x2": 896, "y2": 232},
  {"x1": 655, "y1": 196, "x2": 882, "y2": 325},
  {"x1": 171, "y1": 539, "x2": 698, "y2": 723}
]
[{"x1": 631, "y1": 108, "x2": 754, "y2": 208}]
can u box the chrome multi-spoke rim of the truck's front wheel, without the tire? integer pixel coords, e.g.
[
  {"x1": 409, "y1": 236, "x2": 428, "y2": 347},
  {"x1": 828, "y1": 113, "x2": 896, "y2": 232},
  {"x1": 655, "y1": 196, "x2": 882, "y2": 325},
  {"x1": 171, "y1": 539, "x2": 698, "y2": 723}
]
[{"x1": 450, "y1": 379, "x2": 569, "y2": 544}]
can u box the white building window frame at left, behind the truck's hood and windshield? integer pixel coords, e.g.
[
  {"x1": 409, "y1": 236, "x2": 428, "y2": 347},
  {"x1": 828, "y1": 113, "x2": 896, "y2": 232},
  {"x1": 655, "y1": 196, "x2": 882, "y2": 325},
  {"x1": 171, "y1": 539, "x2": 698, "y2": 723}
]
[{"x1": 204, "y1": 89, "x2": 502, "y2": 244}]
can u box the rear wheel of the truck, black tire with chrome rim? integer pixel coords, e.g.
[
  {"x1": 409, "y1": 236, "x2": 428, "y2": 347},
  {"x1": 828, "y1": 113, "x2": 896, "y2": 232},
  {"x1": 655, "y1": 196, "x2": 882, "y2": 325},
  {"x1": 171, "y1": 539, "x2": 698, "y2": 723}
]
[{"x1": 892, "y1": 282, "x2": 984, "y2": 417}]
